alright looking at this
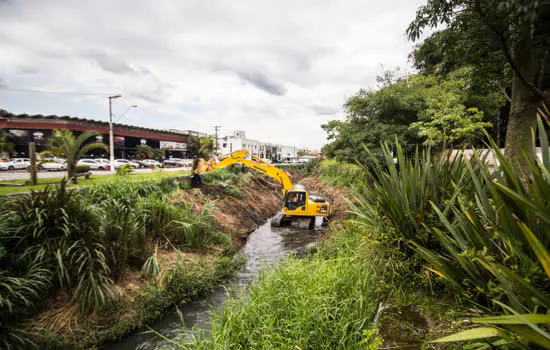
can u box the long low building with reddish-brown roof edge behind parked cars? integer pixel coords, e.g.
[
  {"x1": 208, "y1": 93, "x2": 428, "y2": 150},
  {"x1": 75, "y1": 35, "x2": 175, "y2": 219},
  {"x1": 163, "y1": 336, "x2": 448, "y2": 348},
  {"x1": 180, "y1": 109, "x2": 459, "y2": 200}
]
[{"x1": 0, "y1": 109, "x2": 198, "y2": 159}]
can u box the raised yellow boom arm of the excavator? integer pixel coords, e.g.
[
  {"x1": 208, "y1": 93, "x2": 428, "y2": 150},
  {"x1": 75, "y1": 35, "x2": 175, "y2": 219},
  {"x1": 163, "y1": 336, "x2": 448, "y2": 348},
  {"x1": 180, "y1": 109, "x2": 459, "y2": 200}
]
[{"x1": 192, "y1": 150, "x2": 294, "y2": 196}]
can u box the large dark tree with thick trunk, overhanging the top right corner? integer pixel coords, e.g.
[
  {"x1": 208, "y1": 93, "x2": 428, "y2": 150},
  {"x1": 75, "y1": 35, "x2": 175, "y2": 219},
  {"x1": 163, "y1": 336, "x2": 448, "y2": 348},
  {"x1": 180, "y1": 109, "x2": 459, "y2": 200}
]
[{"x1": 407, "y1": 0, "x2": 550, "y2": 172}]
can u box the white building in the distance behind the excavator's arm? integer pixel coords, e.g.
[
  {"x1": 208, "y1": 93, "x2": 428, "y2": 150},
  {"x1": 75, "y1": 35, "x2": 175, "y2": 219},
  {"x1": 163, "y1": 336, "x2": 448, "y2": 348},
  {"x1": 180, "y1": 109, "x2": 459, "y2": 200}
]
[{"x1": 218, "y1": 130, "x2": 297, "y2": 161}]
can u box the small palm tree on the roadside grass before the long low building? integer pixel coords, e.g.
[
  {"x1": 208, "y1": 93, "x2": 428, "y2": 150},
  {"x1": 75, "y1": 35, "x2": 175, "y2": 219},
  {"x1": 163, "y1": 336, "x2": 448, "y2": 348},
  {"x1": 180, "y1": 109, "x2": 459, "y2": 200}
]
[{"x1": 48, "y1": 129, "x2": 107, "y2": 183}]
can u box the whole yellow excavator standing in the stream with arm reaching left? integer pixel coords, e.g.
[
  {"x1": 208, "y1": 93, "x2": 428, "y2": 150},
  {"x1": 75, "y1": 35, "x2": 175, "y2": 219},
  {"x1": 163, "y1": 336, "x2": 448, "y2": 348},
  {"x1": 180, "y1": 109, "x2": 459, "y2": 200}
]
[{"x1": 191, "y1": 150, "x2": 330, "y2": 227}]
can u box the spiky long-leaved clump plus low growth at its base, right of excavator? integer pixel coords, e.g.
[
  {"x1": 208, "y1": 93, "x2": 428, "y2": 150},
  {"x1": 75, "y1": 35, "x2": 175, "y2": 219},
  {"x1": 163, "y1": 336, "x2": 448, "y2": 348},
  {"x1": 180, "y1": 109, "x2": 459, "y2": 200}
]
[{"x1": 350, "y1": 144, "x2": 472, "y2": 289}]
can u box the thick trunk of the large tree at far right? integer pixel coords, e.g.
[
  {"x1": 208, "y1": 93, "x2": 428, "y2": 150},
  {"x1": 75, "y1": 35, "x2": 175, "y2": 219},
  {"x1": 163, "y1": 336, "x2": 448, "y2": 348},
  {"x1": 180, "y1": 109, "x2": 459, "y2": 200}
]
[{"x1": 505, "y1": 27, "x2": 539, "y2": 177}]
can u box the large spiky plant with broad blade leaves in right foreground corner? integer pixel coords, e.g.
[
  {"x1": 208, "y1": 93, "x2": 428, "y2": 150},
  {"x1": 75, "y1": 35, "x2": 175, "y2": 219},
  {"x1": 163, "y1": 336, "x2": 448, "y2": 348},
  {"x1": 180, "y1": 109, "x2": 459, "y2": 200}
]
[{"x1": 415, "y1": 119, "x2": 550, "y2": 348}]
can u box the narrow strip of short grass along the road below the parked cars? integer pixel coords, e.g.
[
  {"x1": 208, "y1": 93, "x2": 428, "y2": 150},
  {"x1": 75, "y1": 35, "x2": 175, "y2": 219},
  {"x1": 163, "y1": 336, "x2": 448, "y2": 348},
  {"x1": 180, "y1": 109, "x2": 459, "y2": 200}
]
[{"x1": 0, "y1": 170, "x2": 189, "y2": 195}]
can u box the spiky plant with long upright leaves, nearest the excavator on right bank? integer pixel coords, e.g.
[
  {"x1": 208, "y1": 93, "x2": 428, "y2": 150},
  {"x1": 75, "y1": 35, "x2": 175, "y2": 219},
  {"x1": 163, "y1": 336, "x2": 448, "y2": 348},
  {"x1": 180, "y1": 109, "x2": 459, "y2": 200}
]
[{"x1": 351, "y1": 144, "x2": 472, "y2": 260}]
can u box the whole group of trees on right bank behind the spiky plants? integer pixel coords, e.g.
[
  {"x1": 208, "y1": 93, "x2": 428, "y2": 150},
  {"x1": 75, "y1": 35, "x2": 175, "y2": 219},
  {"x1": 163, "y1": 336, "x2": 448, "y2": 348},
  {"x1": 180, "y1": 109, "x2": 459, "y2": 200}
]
[{"x1": 322, "y1": 0, "x2": 550, "y2": 175}]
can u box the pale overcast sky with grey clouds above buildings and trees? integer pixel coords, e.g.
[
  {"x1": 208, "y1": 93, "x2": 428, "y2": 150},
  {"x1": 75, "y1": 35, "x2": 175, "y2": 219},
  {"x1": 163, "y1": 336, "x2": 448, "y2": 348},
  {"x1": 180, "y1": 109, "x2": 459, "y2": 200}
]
[{"x1": 0, "y1": 0, "x2": 425, "y2": 149}]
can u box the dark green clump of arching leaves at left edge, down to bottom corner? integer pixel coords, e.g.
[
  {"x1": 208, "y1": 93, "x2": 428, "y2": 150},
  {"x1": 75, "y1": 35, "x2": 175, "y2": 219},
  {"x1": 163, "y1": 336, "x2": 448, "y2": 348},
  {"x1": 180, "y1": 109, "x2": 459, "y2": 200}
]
[{"x1": 0, "y1": 184, "x2": 114, "y2": 346}]
